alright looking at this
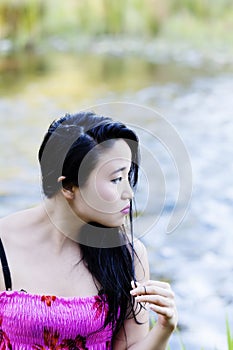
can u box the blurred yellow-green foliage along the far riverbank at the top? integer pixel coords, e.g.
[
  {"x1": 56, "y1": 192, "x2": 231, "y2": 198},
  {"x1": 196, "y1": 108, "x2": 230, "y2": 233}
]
[{"x1": 0, "y1": 0, "x2": 233, "y2": 48}]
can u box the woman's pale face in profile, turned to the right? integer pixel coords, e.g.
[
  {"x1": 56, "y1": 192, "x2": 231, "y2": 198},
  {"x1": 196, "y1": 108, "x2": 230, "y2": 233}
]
[{"x1": 71, "y1": 139, "x2": 133, "y2": 227}]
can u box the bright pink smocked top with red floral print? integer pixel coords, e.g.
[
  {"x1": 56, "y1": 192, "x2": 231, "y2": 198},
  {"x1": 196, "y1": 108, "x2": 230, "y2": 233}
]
[{"x1": 0, "y1": 291, "x2": 112, "y2": 350}]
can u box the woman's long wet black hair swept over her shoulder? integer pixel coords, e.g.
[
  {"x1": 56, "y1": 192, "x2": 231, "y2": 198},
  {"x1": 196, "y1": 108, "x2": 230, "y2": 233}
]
[{"x1": 39, "y1": 112, "x2": 143, "y2": 344}]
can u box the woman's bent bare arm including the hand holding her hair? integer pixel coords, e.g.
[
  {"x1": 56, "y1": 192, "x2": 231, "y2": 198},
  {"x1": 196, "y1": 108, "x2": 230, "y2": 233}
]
[{"x1": 113, "y1": 242, "x2": 177, "y2": 350}]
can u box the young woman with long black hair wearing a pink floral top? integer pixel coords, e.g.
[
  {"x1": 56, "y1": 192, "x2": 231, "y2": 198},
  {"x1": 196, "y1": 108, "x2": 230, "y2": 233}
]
[{"x1": 0, "y1": 112, "x2": 177, "y2": 350}]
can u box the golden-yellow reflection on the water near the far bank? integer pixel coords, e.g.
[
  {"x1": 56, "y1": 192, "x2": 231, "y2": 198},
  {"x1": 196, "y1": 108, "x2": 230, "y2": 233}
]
[{"x1": 0, "y1": 51, "x2": 229, "y2": 98}]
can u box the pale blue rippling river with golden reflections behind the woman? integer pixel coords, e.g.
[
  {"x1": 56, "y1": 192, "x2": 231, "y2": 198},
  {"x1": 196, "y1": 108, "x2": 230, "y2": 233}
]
[{"x1": 0, "y1": 37, "x2": 233, "y2": 350}]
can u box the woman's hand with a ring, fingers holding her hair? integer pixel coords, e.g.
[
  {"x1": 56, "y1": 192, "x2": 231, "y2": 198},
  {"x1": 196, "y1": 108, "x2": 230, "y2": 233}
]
[{"x1": 130, "y1": 280, "x2": 178, "y2": 332}]
